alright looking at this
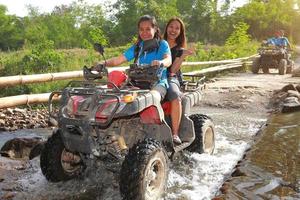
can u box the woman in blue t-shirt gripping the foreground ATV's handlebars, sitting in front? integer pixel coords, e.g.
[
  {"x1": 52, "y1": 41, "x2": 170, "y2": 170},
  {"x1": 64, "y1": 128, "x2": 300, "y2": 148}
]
[{"x1": 94, "y1": 15, "x2": 172, "y2": 101}]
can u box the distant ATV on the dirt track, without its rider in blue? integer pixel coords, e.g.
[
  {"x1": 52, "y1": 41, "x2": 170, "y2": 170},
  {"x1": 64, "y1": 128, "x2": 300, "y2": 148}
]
[{"x1": 252, "y1": 45, "x2": 294, "y2": 75}]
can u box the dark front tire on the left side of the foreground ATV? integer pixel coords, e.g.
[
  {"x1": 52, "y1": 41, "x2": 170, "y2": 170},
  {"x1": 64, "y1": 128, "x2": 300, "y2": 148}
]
[{"x1": 40, "y1": 131, "x2": 85, "y2": 182}]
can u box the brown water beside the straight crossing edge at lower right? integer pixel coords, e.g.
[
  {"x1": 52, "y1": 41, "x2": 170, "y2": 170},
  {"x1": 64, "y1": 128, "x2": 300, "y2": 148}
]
[{"x1": 221, "y1": 112, "x2": 300, "y2": 199}]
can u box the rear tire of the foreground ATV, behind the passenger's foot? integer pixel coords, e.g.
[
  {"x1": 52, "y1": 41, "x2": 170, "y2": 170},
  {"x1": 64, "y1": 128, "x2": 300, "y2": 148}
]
[{"x1": 188, "y1": 114, "x2": 215, "y2": 154}]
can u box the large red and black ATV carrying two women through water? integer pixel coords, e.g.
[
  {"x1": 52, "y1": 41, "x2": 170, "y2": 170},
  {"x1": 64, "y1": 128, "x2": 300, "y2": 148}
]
[{"x1": 40, "y1": 45, "x2": 215, "y2": 200}]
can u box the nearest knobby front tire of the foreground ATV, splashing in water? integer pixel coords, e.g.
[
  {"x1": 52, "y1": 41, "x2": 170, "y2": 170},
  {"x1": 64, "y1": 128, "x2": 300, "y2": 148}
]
[{"x1": 119, "y1": 138, "x2": 169, "y2": 200}]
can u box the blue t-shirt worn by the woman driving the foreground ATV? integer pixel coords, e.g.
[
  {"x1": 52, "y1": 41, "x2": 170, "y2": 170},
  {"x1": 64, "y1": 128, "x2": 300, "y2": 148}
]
[{"x1": 123, "y1": 40, "x2": 171, "y2": 88}]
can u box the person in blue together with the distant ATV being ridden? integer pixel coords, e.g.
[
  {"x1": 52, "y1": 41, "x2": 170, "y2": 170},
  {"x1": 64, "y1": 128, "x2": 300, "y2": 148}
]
[{"x1": 252, "y1": 30, "x2": 294, "y2": 75}]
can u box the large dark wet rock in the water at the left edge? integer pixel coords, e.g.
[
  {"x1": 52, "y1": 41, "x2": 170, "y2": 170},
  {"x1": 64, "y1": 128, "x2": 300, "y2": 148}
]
[{"x1": 0, "y1": 137, "x2": 44, "y2": 159}]
